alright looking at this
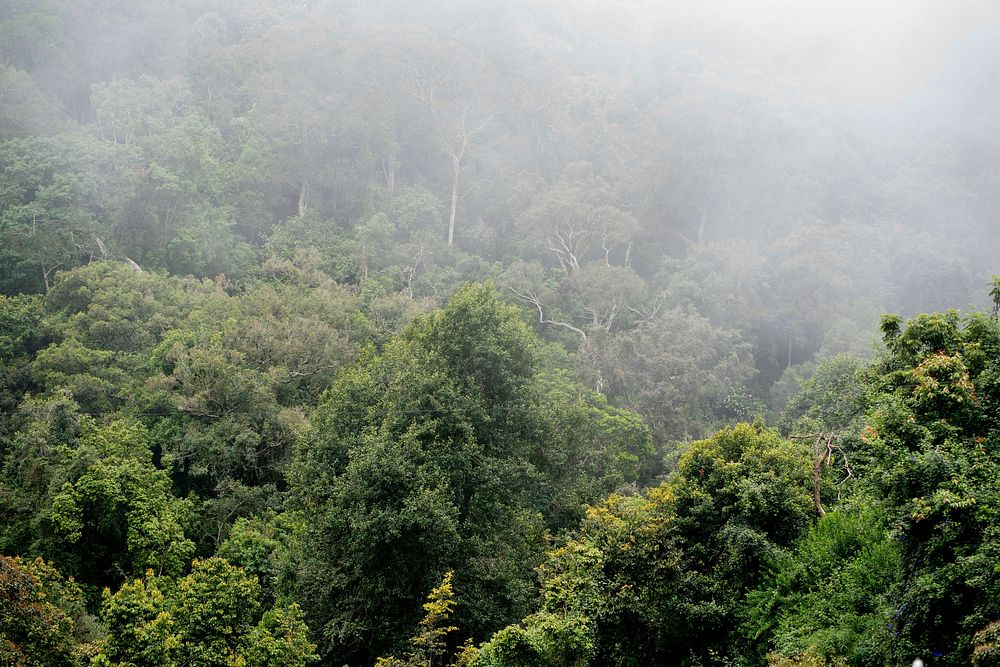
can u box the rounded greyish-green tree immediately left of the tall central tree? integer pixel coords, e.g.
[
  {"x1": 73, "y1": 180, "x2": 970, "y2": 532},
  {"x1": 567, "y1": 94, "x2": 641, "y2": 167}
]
[{"x1": 140, "y1": 283, "x2": 364, "y2": 500}]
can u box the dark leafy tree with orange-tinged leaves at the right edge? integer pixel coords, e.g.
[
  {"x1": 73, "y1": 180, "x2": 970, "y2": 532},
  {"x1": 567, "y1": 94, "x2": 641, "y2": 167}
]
[{"x1": 864, "y1": 311, "x2": 1000, "y2": 665}]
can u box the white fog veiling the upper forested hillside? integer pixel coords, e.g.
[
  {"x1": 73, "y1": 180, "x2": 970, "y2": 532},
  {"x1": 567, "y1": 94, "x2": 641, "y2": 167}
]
[{"x1": 0, "y1": 0, "x2": 1000, "y2": 438}]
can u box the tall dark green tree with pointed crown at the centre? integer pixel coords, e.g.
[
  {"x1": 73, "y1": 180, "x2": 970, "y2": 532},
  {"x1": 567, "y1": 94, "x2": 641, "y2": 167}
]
[{"x1": 293, "y1": 287, "x2": 541, "y2": 659}]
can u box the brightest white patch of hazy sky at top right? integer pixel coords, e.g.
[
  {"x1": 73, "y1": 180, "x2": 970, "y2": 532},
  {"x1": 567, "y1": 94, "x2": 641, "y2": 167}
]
[{"x1": 557, "y1": 0, "x2": 1000, "y2": 106}]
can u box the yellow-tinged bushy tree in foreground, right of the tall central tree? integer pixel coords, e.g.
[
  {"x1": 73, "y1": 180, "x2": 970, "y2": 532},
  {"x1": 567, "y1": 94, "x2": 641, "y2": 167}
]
[{"x1": 475, "y1": 425, "x2": 812, "y2": 665}]
